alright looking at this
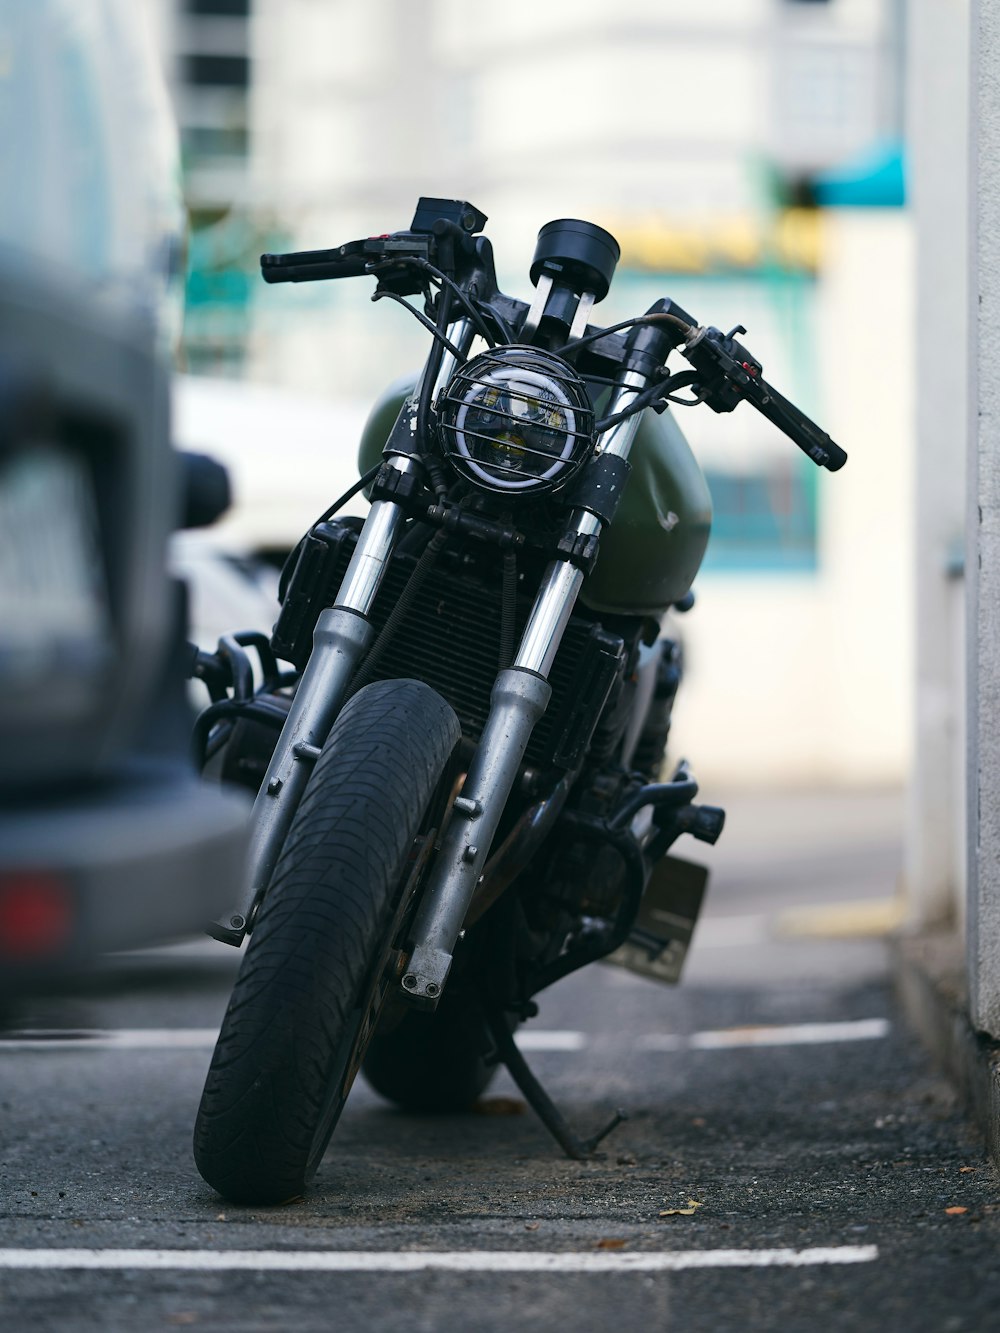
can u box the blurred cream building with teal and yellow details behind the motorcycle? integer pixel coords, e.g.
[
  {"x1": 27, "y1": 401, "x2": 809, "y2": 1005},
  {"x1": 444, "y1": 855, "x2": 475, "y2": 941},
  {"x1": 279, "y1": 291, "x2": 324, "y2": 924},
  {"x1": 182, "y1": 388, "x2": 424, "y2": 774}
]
[{"x1": 147, "y1": 0, "x2": 913, "y2": 782}]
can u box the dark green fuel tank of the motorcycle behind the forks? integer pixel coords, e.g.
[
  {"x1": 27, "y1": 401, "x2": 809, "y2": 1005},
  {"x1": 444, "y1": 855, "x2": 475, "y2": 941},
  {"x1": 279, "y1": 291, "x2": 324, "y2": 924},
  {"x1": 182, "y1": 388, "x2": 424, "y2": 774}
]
[{"x1": 357, "y1": 377, "x2": 712, "y2": 617}]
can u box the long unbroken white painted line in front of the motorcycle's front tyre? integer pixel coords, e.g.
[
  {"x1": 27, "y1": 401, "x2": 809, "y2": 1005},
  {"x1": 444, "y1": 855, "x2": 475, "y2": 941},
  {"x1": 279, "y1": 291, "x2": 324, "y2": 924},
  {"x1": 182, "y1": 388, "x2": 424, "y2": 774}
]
[{"x1": 0, "y1": 1245, "x2": 879, "y2": 1273}]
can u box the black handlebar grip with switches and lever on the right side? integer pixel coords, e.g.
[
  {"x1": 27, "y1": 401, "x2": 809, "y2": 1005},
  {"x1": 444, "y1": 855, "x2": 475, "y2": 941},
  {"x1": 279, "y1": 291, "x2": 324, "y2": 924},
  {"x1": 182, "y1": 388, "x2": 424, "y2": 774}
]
[{"x1": 681, "y1": 324, "x2": 847, "y2": 472}]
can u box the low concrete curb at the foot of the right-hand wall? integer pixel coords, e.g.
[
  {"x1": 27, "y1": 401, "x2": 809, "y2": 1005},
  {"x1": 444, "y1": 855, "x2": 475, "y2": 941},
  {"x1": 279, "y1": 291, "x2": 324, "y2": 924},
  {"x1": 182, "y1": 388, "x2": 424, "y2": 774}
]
[{"x1": 891, "y1": 932, "x2": 1000, "y2": 1170}]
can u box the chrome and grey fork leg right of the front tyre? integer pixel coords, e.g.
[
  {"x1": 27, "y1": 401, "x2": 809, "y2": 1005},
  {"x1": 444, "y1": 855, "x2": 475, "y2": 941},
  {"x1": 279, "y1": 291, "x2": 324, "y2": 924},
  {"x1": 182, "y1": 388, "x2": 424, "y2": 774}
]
[{"x1": 403, "y1": 371, "x2": 645, "y2": 1008}]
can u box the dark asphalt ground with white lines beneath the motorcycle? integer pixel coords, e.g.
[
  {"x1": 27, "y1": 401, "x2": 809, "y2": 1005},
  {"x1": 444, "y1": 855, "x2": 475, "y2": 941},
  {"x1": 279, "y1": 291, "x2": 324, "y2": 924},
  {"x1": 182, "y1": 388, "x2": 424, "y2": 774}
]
[{"x1": 0, "y1": 793, "x2": 1000, "y2": 1333}]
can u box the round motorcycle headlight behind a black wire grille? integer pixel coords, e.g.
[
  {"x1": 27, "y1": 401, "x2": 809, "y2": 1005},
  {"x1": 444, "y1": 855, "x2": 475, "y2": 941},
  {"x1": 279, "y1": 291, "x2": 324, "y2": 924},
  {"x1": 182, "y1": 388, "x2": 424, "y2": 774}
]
[{"x1": 437, "y1": 345, "x2": 593, "y2": 493}]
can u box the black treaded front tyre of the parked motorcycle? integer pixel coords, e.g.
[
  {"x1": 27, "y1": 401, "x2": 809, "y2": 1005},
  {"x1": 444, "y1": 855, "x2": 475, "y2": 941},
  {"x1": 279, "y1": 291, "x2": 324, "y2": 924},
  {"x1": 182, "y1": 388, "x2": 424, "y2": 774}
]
[{"x1": 195, "y1": 680, "x2": 460, "y2": 1204}]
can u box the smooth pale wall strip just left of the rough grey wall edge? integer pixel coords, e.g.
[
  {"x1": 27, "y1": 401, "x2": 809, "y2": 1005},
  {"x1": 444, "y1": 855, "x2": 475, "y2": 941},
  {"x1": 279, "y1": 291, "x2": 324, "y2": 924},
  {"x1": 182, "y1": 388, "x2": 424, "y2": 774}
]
[{"x1": 905, "y1": 0, "x2": 971, "y2": 926}]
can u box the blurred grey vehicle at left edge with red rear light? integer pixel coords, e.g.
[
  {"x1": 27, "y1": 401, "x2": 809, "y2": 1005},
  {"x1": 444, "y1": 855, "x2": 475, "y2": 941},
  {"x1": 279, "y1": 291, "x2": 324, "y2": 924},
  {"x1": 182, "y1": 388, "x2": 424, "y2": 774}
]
[{"x1": 0, "y1": 0, "x2": 245, "y2": 990}]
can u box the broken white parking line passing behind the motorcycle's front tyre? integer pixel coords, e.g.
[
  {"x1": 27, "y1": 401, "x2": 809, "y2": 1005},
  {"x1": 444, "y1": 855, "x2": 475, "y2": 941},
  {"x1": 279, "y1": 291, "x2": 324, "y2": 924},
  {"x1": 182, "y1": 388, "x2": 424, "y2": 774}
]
[{"x1": 0, "y1": 1018, "x2": 891, "y2": 1052}]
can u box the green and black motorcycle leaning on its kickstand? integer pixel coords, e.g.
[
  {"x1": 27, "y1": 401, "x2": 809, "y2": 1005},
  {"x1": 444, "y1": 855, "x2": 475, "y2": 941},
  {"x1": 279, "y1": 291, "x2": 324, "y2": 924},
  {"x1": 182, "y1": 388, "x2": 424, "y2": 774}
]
[{"x1": 192, "y1": 199, "x2": 847, "y2": 1204}]
